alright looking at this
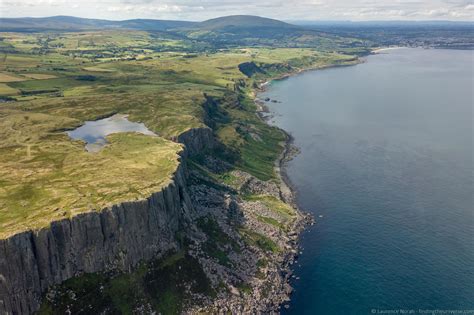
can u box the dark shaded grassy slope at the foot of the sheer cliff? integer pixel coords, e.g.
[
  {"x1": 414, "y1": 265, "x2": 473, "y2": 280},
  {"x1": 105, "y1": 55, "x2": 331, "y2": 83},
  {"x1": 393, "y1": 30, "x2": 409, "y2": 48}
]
[{"x1": 38, "y1": 251, "x2": 215, "y2": 315}]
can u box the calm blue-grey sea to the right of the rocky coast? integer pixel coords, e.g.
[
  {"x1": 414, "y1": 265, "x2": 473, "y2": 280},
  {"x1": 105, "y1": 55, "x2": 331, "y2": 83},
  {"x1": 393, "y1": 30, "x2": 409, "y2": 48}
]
[{"x1": 260, "y1": 49, "x2": 474, "y2": 315}]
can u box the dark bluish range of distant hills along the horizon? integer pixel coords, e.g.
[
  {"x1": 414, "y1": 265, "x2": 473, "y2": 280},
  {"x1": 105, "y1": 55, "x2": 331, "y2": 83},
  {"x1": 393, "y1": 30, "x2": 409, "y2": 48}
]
[{"x1": 0, "y1": 15, "x2": 366, "y2": 50}]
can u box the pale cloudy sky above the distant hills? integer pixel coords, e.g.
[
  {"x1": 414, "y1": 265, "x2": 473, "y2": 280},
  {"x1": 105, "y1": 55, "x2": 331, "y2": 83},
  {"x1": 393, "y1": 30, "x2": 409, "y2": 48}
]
[{"x1": 0, "y1": 0, "x2": 474, "y2": 21}]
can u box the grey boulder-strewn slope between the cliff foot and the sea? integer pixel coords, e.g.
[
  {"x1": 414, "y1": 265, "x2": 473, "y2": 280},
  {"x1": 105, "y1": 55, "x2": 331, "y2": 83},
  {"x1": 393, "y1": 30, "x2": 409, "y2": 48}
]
[{"x1": 186, "y1": 171, "x2": 310, "y2": 314}]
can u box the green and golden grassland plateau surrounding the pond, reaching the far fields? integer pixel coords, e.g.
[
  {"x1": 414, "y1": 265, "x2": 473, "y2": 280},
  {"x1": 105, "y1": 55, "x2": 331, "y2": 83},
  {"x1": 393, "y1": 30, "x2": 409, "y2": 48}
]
[{"x1": 0, "y1": 30, "x2": 360, "y2": 241}]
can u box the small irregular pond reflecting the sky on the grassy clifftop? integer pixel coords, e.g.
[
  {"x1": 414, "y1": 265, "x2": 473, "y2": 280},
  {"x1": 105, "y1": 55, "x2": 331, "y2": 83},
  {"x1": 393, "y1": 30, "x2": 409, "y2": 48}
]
[{"x1": 67, "y1": 114, "x2": 155, "y2": 152}]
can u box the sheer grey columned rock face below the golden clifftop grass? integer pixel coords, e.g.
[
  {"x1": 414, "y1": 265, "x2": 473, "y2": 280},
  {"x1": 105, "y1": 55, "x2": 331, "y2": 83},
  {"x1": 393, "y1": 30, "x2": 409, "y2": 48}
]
[{"x1": 0, "y1": 163, "x2": 194, "y2": 314}]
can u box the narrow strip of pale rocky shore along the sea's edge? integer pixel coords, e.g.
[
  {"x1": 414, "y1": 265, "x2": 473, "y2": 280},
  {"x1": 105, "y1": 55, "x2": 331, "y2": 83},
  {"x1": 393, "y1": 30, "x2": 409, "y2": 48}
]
[{"x1": 199, "y1": 52, "x2": 365, "y2": 314}]
